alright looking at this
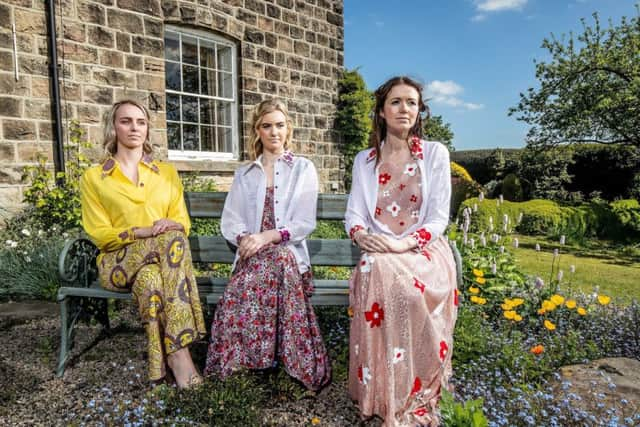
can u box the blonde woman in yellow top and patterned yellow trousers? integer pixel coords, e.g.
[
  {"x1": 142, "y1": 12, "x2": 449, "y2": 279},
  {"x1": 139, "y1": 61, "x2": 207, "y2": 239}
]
[{"x1": 80, "y1": 100, "x2": 205, "y2": 388}]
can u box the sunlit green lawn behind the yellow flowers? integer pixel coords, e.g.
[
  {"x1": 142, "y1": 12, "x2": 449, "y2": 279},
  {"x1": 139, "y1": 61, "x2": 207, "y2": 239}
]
[{"x1": 513, "y1": 236, "x2": 640, "y2": 302}]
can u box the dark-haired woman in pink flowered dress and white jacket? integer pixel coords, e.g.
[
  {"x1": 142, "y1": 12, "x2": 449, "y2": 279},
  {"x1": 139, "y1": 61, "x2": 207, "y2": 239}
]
[{"x1": 345, "y1": 77, "x2": 457, "y2": 426}]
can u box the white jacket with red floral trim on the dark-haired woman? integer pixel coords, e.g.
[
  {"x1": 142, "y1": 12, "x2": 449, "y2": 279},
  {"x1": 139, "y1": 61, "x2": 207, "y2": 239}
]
[{"x1": 345, "y1": 139, "x2": 451, "y2": 249}]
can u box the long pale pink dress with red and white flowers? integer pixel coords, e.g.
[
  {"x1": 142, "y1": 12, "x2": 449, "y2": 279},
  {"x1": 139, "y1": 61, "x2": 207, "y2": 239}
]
[{"x1": 349, "y1": 160, "x2": 458, "y2": 426}]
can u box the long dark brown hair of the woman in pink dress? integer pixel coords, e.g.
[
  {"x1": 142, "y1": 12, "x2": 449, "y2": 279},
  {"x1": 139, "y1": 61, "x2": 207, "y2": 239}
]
[{"x1": 369, "y1": 76, "x2": 429, "y2": 165}]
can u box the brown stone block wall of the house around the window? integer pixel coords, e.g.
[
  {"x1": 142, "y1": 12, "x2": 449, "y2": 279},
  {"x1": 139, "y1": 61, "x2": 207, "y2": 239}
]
[{"x1": 0, "y1": 0, "x2": 344, "y2": 214}]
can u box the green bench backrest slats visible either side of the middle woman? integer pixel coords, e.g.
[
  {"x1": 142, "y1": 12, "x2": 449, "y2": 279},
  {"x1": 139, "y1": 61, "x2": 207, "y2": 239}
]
[{"x1": 185, "y1": 192, "x2": 360, "y2": 267}]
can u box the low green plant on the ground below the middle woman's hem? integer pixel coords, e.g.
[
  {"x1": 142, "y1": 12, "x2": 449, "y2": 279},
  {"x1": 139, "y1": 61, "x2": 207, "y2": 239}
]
[{"x1": 147, "y1": 373, "x2": 266, "y2": 427}]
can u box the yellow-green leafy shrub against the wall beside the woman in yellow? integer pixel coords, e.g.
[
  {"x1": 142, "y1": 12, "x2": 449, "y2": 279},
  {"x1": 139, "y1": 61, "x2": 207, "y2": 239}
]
[{"x1": 23, "y1": 121, "x2": 91, "y2": 230}]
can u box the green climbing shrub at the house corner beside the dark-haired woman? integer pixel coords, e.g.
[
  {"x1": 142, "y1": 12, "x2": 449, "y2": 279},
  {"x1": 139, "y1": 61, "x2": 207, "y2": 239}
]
[{"x1": 336, "y1": 69, "x2": 374, "y2": 191}]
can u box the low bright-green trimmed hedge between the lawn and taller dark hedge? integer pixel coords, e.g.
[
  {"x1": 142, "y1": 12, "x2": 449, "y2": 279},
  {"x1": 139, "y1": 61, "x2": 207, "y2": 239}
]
[{"x1": 458, "y1": 198, "x2": 640, "y2": 240}]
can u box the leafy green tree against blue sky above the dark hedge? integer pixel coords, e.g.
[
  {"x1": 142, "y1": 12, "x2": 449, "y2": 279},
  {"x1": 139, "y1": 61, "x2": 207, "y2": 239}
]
[{"x1": 509, "y1": 4, "x2": 640, "y2": 147}]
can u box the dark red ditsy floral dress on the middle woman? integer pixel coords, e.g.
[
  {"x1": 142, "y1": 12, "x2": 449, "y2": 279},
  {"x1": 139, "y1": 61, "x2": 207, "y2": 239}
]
[{"x1": 205, "y1": 187, "x2": 331, "y2": 390}]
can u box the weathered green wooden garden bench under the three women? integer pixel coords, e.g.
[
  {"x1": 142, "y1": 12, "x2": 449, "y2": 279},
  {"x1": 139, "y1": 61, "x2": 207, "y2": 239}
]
[{"x1": 57, "y1": 192, "x2": 462, "y2": 376}]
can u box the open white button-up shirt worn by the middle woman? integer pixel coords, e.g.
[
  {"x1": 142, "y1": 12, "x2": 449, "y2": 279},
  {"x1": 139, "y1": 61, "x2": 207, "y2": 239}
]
[{"x1": 220, "y1": 151, "x2": 318, "y2": 273}]
